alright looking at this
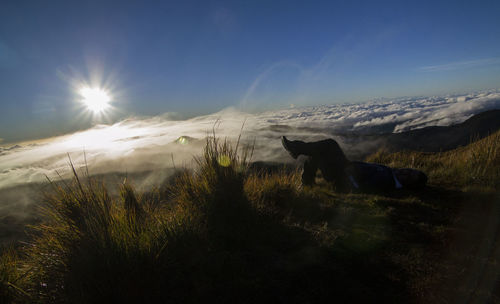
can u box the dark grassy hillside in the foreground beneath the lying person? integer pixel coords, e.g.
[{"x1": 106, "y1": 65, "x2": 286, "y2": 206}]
[{"x1": 0, "y1": 133, "x2": 500, "y2": 303}]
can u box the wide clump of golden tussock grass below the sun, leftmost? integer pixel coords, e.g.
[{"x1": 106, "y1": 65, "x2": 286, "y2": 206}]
[{"x1": 26, "y1": 171, "x2": 177, "y2": 303}]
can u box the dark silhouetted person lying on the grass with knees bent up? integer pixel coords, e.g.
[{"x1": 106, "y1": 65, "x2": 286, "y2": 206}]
[{"x1": 281, "y1": 136, "x2": 427, "y2": 192}]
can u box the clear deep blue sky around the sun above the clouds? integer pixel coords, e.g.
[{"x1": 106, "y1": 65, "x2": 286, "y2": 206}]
[{"x1": 0, "y1": 0, "x2": 500, "y2": 141}]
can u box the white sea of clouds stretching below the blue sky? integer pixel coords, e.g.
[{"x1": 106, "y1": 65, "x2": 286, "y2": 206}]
[{"x1": 0, "y1": 90, "x2": 500, "y2": 192}]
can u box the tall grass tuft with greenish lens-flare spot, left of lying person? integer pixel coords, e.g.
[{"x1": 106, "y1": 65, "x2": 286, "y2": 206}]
[{"x1": 166, "y1": 137, "x2": 254, "y2": 244}]
